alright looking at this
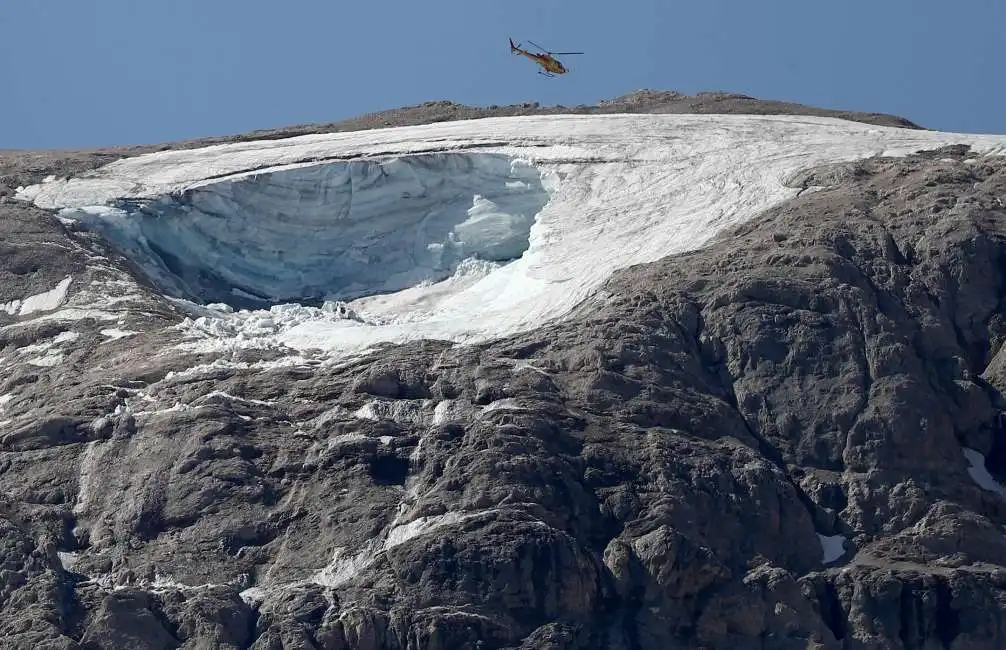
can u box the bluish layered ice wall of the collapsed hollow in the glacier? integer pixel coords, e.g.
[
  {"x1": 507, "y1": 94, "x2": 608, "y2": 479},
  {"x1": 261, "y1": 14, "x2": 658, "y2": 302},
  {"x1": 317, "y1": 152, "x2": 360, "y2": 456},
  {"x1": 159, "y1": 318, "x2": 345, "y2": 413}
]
[{"x1": 64, "y1": 152, "x2": 549, "y2": 307}]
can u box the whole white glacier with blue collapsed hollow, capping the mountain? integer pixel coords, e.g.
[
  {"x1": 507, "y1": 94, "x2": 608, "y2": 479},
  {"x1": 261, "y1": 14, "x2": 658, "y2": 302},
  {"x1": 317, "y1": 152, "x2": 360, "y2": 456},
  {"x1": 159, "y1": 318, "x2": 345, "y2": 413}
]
[{"x1": 17, "y1": 114, "x2": 1006, "y2": 356}]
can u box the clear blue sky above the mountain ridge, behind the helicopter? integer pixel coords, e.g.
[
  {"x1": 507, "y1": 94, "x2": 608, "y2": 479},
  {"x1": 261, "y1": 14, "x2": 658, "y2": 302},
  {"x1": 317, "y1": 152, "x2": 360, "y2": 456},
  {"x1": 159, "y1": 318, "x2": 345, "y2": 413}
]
[{"x1": 0, "y1": 0, "x2": 1006, "y2": 149}]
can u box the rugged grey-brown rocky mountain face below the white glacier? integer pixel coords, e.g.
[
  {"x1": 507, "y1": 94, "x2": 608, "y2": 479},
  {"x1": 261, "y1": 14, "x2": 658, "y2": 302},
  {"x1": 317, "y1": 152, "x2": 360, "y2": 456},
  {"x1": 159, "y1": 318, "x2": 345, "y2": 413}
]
[{"x1": 0, "y1": 96, "x2": 1006, "y2": 650}]
